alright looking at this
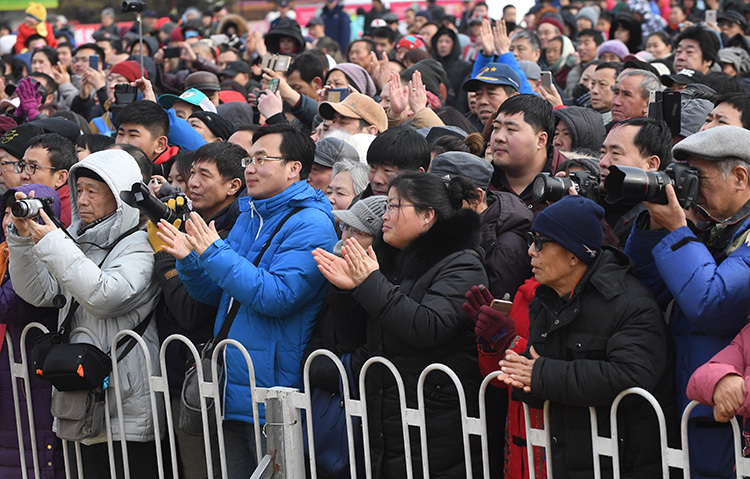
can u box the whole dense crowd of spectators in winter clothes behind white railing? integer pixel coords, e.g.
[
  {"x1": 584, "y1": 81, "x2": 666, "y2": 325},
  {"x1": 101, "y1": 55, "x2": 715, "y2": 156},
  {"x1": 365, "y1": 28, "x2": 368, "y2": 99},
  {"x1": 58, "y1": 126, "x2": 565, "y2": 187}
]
[{"x1": 0, "y1": 0, "x2": 750, "y2": 479}]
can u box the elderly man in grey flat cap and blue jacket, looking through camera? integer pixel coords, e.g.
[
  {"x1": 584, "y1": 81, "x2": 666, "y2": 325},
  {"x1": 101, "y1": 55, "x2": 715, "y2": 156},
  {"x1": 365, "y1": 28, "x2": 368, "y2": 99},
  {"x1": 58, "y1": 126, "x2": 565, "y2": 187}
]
[{"x1": 625, "y1": 126, "x2": 750, "y2": 478}]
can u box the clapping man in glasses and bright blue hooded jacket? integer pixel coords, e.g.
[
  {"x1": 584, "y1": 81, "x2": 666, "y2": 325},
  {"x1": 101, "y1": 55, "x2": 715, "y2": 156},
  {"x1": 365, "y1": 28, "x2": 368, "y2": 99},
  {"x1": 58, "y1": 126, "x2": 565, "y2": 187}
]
[{"x1": 160, "y1": 124, "x2": 336, "y2": 478}]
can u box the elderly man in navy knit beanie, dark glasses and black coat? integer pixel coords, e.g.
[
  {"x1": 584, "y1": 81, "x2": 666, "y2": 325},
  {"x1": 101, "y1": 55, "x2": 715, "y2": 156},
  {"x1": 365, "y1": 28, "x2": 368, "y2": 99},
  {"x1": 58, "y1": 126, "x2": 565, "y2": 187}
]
[{"x1": 494, "y1": 196, "x2": 674, "y2": 478}]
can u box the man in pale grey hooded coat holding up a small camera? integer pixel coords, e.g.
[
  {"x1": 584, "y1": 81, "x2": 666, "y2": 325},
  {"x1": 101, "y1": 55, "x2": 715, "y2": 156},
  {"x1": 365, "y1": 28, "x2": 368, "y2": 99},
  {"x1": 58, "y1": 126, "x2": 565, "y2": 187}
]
[{"x1": 7, "y1": 150, "x2": 165, "y2": 477}]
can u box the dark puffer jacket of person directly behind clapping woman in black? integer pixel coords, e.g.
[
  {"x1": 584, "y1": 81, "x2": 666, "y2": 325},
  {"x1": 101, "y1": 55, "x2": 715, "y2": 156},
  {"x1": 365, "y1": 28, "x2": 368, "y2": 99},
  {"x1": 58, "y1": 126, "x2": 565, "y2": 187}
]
[{"x1": 480, "y1": 191, "x2": 534, "y2": 298}]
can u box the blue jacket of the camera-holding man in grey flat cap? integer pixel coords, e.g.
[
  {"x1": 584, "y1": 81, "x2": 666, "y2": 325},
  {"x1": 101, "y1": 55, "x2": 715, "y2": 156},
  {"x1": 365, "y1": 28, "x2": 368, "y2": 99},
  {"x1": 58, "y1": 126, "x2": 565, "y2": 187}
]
[{"x1": 625, "y1": 220, "x2": 750, "y2": 417}]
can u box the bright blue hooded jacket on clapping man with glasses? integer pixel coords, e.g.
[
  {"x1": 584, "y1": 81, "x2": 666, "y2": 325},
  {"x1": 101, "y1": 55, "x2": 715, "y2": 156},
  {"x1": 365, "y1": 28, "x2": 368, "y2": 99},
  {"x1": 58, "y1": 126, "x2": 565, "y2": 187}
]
[{"x1": 177, "y1": 181, "x2": 336, "y2": 423}]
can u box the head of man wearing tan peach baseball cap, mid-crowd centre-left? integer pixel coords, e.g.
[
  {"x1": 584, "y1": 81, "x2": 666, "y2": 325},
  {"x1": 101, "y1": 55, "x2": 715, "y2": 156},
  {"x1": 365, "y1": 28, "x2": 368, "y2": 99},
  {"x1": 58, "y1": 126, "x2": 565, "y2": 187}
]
[{"x1": 318, "y1": 92, "x2": 388, "y2": 135}]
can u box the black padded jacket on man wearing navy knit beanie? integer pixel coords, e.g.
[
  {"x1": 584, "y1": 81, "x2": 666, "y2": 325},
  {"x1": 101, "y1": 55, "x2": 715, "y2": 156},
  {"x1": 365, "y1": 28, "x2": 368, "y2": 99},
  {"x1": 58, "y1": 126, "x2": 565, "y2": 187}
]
[{"x1": 514, "y1": 247, "x2": 676, "y2": 479}]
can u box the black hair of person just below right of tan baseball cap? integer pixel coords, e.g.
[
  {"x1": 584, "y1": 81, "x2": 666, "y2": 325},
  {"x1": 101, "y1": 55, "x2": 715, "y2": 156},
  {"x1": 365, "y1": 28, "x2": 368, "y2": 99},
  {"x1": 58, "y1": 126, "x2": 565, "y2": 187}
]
[{"x1": 367, "y1": 125, "x2": 430, "y2": 171}]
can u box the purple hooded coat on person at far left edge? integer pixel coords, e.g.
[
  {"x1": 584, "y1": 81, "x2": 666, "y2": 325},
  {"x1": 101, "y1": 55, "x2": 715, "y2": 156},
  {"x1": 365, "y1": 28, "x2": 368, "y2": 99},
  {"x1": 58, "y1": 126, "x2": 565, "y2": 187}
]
[{"x1": 0, "y1": 185, "x2": 65, "y2": 479}]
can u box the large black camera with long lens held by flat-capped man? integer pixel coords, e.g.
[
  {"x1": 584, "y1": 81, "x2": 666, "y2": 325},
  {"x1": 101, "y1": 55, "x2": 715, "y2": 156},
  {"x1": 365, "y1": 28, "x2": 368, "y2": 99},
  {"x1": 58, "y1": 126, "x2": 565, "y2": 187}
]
[{"x1": 604, "y1": 163, "x2": 698, "y2": 208}]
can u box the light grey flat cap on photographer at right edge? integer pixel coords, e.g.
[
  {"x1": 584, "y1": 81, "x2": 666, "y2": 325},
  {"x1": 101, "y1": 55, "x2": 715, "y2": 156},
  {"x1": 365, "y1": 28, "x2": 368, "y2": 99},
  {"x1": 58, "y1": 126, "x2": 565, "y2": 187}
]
[{"x1": 672, "y1": 125, "x2": 750, "y2": 163}]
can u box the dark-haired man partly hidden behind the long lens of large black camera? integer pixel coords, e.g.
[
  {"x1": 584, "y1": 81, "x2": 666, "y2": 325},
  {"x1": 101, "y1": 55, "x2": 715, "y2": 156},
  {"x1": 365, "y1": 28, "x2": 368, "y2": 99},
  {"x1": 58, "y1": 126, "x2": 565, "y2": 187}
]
[{"x1": 599, "y1": 118, "x2": 672, "y2": 247}]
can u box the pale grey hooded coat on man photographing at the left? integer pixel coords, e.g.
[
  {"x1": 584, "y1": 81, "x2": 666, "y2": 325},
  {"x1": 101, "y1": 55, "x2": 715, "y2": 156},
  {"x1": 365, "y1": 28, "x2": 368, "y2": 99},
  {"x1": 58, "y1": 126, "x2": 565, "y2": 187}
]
[{"x1": 8, "y1": 150, "x2": 165, "y2": 445}]
